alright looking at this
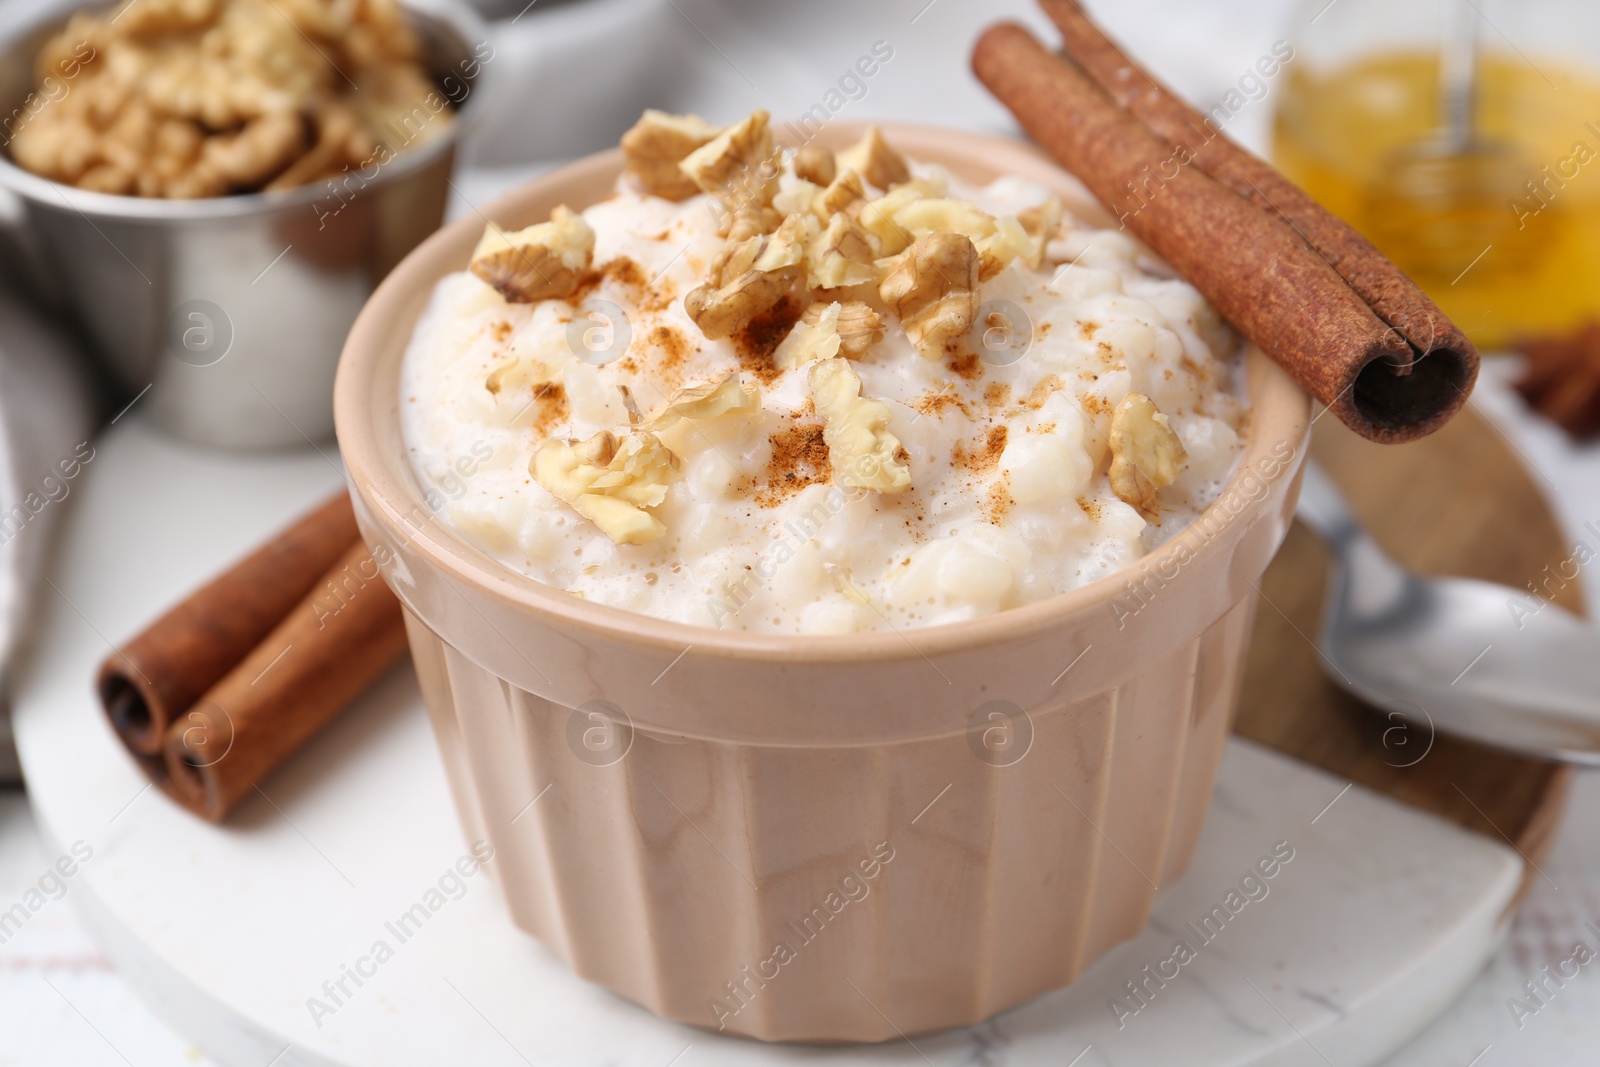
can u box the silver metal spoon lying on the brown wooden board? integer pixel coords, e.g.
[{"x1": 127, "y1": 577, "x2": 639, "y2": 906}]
[{"x1": 1296, "y1": 462, "x2": 1600, "y2": 765}]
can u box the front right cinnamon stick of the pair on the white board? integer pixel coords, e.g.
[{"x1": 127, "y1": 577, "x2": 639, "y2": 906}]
[{"x1": 165, "y1": 542, "x2": 406, "y2": 822}]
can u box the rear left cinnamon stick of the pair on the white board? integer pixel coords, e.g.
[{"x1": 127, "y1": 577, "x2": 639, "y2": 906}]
[{"x1": 96, "y1": 490, "x2": 360, "y2": 767}]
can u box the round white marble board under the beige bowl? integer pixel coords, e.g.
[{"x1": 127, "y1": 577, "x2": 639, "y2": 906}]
[{"x1": 16, "y1": 414, "x2": 1523, "y2": 1067}]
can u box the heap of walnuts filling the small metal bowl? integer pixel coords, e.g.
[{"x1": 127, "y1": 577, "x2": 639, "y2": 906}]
[{"x1": 6, "y1": 0, "x2": 453, "y2": 198}]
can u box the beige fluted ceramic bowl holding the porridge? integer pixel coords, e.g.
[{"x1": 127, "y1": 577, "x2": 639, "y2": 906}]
[{"x1": 334, "y1": 125, "x2": 1309, "y2": 1041}]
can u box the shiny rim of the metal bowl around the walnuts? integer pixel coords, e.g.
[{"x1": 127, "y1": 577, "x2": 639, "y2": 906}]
[{"x1": 0, "y1": 0, "x2": 493, "y2": 224}]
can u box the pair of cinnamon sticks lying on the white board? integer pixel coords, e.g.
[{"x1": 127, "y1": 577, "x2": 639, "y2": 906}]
[{"x1": 96, "y1": 491, "x2": 406, "y2": 822}]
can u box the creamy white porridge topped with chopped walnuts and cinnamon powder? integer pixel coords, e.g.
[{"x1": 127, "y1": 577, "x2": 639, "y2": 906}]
[{"x1": 402, "y1": 112, "x2": 1245, "y2": 633}]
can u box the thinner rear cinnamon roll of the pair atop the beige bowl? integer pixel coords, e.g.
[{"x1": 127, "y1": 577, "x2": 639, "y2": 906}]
[{"x1": 1040, "y1": 0, "x2": 1478, "y2": 379}]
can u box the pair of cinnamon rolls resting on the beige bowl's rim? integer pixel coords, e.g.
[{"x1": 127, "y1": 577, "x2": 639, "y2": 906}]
[{"x1": 973, "y1": 0, "x2": 1478, "y2": 443}]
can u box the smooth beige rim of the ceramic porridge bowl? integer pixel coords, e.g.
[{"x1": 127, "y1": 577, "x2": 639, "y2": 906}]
[{"x1": 334, "y1": 122, "x2": 1312, "y2": 664}]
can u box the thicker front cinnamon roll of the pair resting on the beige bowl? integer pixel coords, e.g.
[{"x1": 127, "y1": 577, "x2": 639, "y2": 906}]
[{"x1": 973, "y1": 24, "x2": 1477, "y2": 442}]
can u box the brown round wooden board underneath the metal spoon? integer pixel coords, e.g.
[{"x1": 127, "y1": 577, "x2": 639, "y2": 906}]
[{"x1": 1234, "y1": 408, "x2": 1582, "y2": 888}]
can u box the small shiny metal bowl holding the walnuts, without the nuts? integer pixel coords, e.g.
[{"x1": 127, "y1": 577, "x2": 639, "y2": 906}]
[{"x1": 0, "y1": 0, "x2": 494, "y2": 448}]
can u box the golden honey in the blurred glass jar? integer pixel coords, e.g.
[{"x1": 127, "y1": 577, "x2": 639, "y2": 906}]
[{"x1": 1274, "y1": 51, "x2": 1600, "y2": 350}]
